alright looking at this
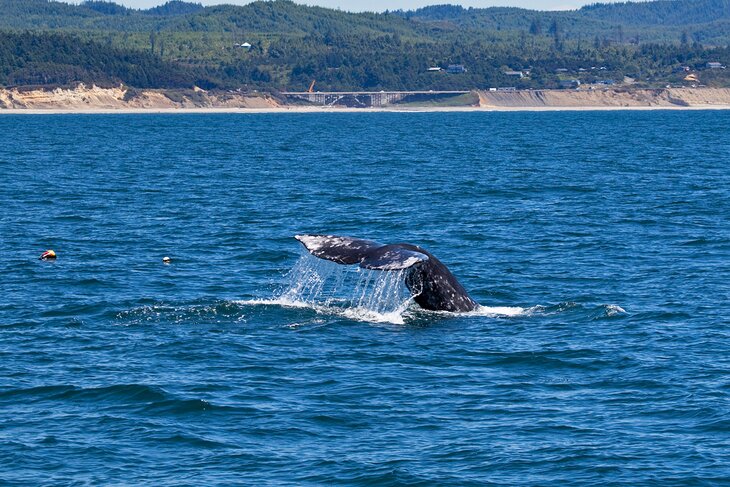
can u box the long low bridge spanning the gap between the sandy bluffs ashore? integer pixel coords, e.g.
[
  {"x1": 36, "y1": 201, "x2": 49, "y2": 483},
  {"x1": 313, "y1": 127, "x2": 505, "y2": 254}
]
[{"x1": 281, "y1": 91, "x2": 469, "y2": 108}]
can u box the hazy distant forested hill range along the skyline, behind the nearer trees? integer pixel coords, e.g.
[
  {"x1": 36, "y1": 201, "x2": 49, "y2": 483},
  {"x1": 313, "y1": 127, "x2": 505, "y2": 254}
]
[{"x1": 0, "y1": 0, "x2": 730, "y2": 45}]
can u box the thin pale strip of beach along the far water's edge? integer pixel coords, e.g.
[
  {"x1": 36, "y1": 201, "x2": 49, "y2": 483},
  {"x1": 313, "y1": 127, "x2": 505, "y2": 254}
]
[{"x1": 0, "y1": 104, "x2": 730, "y2": 116}]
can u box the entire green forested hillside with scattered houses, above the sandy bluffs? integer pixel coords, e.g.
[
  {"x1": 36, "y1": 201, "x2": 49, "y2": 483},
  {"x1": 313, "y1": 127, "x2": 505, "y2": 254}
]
[{"x1": 0, "y1": 0, "x2": 730, "y2": 91}]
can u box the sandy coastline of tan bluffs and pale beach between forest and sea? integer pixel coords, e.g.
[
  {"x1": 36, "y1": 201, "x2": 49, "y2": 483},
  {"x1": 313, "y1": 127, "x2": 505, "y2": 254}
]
[{"x1": 0, "y1": 84, "x2": 730, "y2": 115}]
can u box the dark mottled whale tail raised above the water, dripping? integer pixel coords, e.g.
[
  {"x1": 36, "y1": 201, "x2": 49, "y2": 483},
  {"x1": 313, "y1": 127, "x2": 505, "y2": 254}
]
[{"x1": 294, "y1": 235, "x2": 479, "y2": 313}]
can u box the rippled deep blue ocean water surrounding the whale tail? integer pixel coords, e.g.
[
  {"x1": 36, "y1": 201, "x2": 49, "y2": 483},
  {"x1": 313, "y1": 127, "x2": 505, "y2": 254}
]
[{"x1": 0, "y1": 111, "x2": 730, "y2": 486}]
